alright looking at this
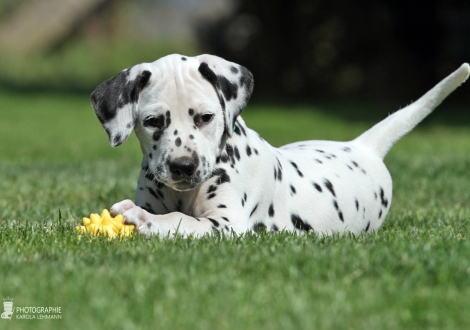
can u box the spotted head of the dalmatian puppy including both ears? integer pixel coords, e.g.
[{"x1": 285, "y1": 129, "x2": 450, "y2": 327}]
[{"x1": 91, "y1": 55, "x2": 253, "y2": 191}]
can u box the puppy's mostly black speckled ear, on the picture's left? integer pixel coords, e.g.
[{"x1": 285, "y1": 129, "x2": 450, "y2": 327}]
[{"x1": 91, "y1": 63, "x2": 152, "y2": 147}]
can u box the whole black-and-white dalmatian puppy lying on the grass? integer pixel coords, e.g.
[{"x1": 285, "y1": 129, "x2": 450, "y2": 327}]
[{"x1": 91, "y1": 55, "x2": 470, "y2": 237}]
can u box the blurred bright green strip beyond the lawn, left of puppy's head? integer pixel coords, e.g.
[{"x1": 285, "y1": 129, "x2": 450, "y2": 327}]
[{"x1": 0, "y1": 39, "x2": 198, "y2": 93}]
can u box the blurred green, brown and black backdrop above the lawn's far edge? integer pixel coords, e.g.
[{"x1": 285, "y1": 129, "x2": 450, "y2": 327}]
[{"x1": 0, "y1": 0, "x2": 470, "y2": 102}]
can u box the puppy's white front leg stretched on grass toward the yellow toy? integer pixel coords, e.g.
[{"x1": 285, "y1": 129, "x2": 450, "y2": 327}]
[{"x1": 110, "y1": 200, "x2": 232, "y2": 237}]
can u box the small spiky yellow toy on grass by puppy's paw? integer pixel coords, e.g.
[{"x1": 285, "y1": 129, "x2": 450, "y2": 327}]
[{"x1": 75, "y1": 209, "x2": 135, "y2": 240}]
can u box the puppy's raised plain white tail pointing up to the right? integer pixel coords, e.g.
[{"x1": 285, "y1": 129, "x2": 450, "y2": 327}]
[{"x1": 354, "y1": 63, "x2": 470, "y2": 159}]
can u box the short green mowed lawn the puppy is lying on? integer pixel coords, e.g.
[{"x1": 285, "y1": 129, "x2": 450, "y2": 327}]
[{"x1": 0, "y1": 91, "x2": 470, "y2": 329}]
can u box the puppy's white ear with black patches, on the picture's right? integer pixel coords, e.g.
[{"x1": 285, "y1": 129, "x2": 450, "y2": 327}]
[{"x1": 198, "y1": 55, "x2": 254, "y2": 136}]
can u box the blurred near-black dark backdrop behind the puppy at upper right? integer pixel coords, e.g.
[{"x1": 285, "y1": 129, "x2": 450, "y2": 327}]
[{"x1": 199, "y1": 0, "x2": 470, "y2": 103}]
